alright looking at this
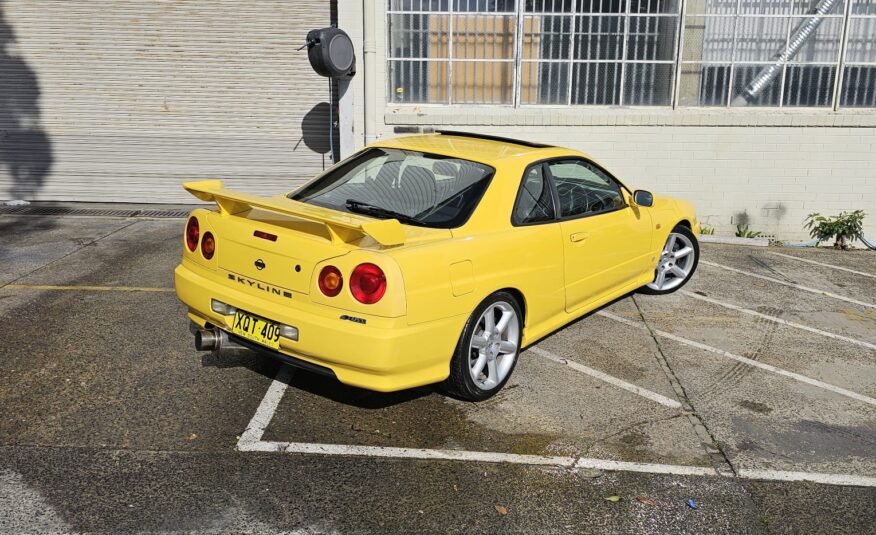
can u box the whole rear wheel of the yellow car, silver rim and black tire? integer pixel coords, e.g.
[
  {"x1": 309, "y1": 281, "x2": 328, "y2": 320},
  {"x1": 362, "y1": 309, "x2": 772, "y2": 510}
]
[{"x1": 444, "y1": 292, "x2": 523, "y2": 401}]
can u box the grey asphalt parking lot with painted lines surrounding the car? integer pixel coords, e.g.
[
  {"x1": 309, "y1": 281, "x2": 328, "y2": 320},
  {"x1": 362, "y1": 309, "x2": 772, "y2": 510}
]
[{"x1": 0, "y1": 216, "x2": 876, "y2": 533}]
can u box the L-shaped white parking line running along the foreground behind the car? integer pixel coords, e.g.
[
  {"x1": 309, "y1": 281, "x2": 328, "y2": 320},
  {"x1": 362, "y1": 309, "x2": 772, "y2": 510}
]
[{"x1": 237, "y1": 366, "x2": 876, "y2": 487}]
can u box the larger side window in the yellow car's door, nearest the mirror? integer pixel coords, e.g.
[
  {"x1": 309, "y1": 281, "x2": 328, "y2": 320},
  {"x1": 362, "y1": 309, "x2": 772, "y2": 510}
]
[{"x1": 548, "y1": 160, "x2": 625, "y2": 217}]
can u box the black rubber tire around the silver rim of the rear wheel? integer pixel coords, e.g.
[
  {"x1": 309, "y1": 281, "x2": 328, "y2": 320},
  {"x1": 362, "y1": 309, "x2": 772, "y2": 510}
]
[{"x1": 441, "y1": 292, "x2": 524, "y2": 401}]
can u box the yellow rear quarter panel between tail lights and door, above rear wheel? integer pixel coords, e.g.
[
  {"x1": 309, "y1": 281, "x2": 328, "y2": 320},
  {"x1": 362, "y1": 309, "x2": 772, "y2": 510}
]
[{"x1": 393, "y1": 160, "x2": 564, "y2": 344}]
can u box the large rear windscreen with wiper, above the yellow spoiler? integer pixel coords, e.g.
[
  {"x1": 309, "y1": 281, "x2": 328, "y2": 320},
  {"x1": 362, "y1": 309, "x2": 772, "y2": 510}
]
[{"x1": 289, "y1": 148, "x2": 494, "y2": 228}]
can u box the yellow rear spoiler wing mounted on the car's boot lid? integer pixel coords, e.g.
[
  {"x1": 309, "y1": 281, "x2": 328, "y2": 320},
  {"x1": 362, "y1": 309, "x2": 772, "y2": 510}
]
[{"x1": 183, "y1": 180, "x2": 405, "y2": 246}]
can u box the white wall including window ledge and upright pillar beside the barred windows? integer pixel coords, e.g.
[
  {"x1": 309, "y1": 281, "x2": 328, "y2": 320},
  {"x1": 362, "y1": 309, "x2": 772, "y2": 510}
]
[{"x1": 339, "y1": 0, "x2": 876, "y2": 245}]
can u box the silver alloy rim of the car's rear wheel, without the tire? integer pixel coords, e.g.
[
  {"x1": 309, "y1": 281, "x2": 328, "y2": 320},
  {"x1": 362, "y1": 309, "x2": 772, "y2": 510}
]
[{"x1": 468, "y1": 301, "x2": 520, "y2": 390}]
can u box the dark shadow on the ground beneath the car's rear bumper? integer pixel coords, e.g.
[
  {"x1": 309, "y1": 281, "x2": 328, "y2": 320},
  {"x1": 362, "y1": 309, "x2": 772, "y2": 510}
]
[{"x1": 201, "y1": 350, "x2": 437, "y2": 410}]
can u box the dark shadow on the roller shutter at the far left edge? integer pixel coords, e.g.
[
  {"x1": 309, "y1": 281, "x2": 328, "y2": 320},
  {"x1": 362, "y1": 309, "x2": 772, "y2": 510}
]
[{"x1": 0, "y1": 0, "x2": 53, "y2": 200}]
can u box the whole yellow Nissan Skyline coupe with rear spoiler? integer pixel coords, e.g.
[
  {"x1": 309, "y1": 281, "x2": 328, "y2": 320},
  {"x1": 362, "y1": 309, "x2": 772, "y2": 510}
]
[{"x1": 175, "y1": 131, "x2": 699, "y2": 400}]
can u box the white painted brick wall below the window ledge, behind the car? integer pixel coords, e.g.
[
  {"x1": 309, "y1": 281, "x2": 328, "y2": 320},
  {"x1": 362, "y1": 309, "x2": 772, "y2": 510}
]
[{"x1": 381, "y1": 119, "x2": 876, "y2": 241}]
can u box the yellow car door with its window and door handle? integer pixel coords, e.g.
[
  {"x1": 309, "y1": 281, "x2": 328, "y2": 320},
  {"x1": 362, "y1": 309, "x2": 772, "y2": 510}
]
[{"x1": 546, "y1": 158, "x2": 653, "y2": 311}]
